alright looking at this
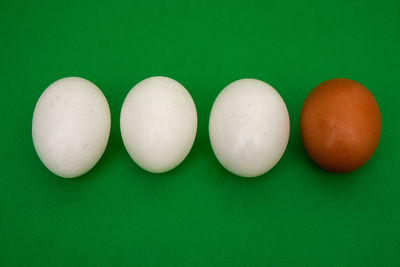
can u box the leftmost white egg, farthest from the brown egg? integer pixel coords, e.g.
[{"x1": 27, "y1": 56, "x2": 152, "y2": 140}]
[{"x1": 32, "y1": 77, "x2": 111, "y2": 178}]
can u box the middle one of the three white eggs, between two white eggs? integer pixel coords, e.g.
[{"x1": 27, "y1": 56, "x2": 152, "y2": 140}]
[{"x1": 120, "y1": 76, "x2": 197, "y2": 173}]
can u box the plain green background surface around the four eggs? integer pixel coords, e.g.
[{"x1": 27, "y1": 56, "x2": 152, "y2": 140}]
[{"x1": 0, "y1": 0, "x2": 400, "y2": 266}]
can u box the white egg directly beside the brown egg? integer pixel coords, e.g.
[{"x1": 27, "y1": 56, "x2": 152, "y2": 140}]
[{"x1": 209, "y1": 79, "x2": 290, "y2": 177}]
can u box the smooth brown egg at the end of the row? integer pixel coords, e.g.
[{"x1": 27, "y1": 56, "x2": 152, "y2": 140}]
[{"x1": 300, "y1": 79, "x2": 381, "y2": 172}]
